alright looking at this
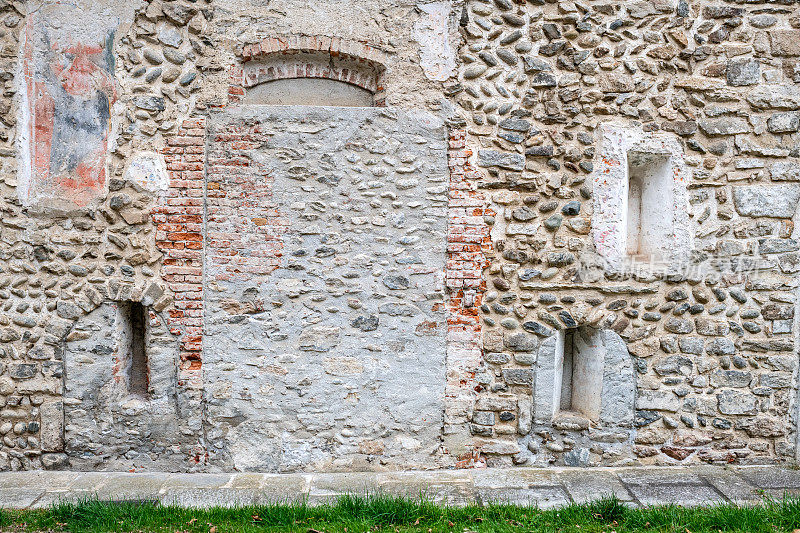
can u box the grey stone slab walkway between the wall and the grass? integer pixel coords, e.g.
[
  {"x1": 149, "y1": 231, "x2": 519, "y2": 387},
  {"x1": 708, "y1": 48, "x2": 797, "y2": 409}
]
[{"x1": 0, "y1": 466, "x2": 800, "y2": 509}]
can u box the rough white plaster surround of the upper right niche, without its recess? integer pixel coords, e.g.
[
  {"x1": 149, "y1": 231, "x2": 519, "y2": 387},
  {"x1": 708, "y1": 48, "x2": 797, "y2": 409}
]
[{"x1": 592, "y1": 124, "x2": 692, "y2": 272}]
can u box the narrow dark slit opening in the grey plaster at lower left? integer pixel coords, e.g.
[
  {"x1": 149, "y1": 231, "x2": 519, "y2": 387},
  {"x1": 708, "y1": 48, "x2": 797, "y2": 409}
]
[{"x1": 120, "y1": 302, "x2": 150, "y2": 398}]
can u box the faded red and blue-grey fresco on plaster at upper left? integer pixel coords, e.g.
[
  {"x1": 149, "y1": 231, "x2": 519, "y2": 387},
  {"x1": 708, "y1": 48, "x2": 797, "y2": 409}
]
[{"x1": 20, "y1": 5, "x2": 119, "y2": 206}]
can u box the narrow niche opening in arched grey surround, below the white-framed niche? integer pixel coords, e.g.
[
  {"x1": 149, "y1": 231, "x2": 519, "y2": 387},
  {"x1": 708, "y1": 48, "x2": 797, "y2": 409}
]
[{"x1": 555, "y1": 328, "x2": 605, "y2": 421}]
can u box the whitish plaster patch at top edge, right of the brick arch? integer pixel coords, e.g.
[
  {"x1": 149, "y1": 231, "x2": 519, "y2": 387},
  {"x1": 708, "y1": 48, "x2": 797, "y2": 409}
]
[{"x1": 414, "y1": 2, "x2": 456, "y2": 81}]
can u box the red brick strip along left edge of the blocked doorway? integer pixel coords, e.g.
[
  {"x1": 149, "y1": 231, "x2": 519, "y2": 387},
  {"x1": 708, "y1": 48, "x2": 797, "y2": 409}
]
[{"x1": 153, "y1": 118, "x2": 205, "y2": 386}]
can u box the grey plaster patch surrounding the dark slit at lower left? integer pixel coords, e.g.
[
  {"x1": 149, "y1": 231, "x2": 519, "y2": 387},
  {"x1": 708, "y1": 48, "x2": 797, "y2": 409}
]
[{"x1": 64, "y1": 302, "x2": 189, "y2": 470}]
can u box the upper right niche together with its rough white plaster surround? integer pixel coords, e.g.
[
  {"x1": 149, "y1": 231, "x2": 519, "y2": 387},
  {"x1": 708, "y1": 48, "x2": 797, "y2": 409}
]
[{"x1": 592, "y1": 124, "x2": 693, "y2": 273}]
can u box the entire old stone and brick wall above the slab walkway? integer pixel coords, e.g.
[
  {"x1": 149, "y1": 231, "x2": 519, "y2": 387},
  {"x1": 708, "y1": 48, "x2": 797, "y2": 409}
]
[{"x1": 0, "y1": 0, "x2": 800, "y2": 471}]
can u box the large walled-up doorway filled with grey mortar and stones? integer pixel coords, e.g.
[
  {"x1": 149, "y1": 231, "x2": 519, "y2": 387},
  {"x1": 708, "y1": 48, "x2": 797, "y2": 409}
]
[{"x1": 204, "y1": 106, "x2": 448, "y2": 471}]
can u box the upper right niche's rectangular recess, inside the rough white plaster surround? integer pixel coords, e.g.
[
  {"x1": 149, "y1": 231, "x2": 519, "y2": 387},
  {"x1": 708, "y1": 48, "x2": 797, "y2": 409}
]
[{"x1": 626, "y1": 151, "x2": 675, "y2": 262}]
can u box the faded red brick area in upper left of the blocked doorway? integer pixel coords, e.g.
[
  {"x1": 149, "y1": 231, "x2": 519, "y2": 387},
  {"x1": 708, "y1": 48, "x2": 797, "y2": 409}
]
[{"x1": 206, "y1": 123, "x2": 288, "y2": 281}]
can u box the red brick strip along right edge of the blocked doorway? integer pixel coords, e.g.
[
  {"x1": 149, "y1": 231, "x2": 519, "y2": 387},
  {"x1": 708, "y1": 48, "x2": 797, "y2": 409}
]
[{"x1": 445, "y1": 125, "x2": 494, "y2": 467}]
